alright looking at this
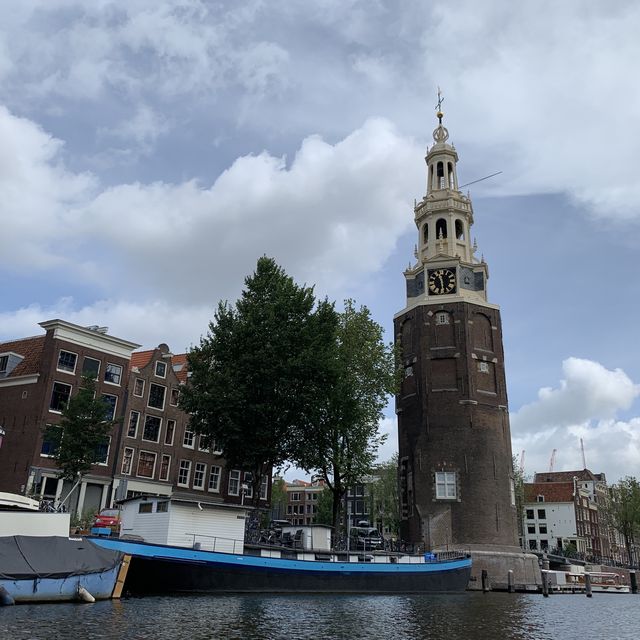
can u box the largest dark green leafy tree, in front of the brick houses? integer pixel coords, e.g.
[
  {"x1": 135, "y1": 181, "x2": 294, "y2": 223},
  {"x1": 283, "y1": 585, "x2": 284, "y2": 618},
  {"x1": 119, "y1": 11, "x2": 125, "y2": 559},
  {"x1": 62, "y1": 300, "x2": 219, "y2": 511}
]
[{"x1": 180, "y1": 257, "x2": 337, "y2": 505}]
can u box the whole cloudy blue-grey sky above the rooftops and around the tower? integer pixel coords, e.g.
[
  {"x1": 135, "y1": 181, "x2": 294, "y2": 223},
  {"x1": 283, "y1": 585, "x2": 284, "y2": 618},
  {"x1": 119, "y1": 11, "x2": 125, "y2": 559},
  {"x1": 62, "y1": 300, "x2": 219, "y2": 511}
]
[{"x1": 0, "y1": 0, "x2": 640, "y2": 482}]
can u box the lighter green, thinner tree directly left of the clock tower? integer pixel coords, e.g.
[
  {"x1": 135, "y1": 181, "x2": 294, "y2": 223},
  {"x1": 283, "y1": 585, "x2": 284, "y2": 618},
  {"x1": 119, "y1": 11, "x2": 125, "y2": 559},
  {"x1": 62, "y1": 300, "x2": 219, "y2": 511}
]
[{"x1": 294, "y1": 300, "x2": 398, "y2": 530}]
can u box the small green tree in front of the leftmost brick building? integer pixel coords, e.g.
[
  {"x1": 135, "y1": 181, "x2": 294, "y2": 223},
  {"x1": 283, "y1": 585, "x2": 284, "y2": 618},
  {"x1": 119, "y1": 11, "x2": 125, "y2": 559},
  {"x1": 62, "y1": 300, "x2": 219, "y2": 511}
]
[{"x1": 50, "y1": 375, "x2": 119, "y2": 480}]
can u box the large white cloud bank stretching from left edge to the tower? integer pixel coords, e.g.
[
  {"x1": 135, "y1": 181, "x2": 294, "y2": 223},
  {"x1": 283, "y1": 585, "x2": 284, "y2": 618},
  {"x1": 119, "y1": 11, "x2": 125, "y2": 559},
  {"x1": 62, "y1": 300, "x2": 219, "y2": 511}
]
[{"x1": 0, "y1": 110, "x2": 424, "y2": 304}]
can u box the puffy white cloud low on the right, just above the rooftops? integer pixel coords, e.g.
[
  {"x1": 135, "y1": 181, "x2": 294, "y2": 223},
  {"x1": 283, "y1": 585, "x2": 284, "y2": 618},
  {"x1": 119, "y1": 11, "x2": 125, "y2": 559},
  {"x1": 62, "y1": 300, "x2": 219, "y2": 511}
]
[{"x1": 511, "y1": 358, "x2": 640, "y2": 481}]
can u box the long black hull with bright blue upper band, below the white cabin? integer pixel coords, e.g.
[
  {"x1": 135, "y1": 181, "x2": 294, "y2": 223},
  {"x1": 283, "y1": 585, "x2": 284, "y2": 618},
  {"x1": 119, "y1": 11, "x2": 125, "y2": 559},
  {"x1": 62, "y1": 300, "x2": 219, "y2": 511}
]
[{"x1": 94, "y1": 538, "x2": 471, "y2": 595}]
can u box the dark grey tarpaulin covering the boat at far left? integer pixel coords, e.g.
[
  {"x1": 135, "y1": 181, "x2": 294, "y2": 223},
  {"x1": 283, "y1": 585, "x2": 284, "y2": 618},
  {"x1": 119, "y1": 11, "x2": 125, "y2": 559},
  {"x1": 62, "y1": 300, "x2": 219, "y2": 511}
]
[{"x1": 0, "y1": 536, "x2": 122, "y2": 580}]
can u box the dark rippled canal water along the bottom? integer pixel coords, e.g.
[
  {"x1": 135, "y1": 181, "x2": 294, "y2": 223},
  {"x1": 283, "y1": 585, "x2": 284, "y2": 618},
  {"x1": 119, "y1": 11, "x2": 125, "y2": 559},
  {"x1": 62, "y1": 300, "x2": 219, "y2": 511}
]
[{"x1": 0, "y1": 593, "x2": 640, "y2": 640}]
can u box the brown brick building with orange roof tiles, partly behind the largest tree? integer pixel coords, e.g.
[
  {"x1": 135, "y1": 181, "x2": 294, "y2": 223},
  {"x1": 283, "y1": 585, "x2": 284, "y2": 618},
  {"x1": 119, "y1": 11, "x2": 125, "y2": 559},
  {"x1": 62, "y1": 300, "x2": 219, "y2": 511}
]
[{"x1": 114, "y1": 344, "x2": 270, "y2": 510}]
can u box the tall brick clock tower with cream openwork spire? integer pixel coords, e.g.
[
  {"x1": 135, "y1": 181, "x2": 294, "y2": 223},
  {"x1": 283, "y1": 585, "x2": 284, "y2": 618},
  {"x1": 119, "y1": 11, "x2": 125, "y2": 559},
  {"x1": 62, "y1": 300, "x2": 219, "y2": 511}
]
[{"x1": 394, "y1": 101, "x2": 518, "y2": 556}]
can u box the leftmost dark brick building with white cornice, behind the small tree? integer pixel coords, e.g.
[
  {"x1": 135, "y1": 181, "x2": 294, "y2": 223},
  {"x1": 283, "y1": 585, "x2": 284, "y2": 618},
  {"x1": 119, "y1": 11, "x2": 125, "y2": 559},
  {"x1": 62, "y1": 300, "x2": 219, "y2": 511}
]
[{"x1": 0, "y1": 320, "x2": 140, "y2": 513}]
